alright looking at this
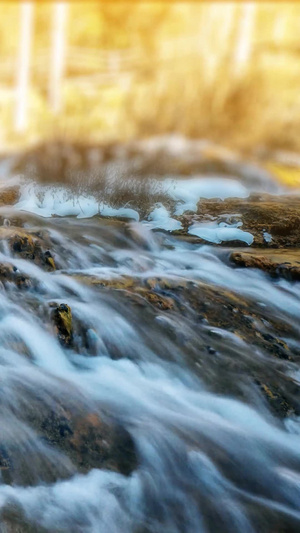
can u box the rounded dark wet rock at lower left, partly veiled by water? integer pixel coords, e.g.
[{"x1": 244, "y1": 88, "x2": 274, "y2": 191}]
[{"x1": 0, "y1": 410, "x2": 137, "y2": 487}]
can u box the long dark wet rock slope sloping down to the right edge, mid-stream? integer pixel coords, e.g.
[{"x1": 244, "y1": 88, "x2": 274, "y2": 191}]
[{"x1": 65, "y1": 272, "x2": 300, "y2": 416}]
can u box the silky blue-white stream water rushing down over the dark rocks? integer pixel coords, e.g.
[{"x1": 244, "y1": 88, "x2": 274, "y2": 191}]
[{"x1": 0, "y1": 178, "x2": 300, "y2": 533}]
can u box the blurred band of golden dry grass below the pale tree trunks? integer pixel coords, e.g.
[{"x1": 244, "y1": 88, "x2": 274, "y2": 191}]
[{"x1": 0, "y1": 47, "x2": 300, "y2": 156}]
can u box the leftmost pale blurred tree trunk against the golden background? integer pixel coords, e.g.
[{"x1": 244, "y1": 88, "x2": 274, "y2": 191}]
[{"x1": 15, "y1": 2, "x2": 33, "y2": 132}]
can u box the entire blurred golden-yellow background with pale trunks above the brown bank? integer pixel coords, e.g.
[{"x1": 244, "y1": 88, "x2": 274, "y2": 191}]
[{"x1": 0, "y1": 1, "x2": 300, "y2": 160}]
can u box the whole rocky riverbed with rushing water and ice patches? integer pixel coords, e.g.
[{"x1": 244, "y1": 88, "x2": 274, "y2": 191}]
[{"x1": 0, "y1": 142, "x2": 300, "y2": 533}]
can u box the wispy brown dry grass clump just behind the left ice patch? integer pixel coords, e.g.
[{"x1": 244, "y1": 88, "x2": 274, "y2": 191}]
[{"x1": 15, "y1": 139, "x2": 174, "y2": 217}]
